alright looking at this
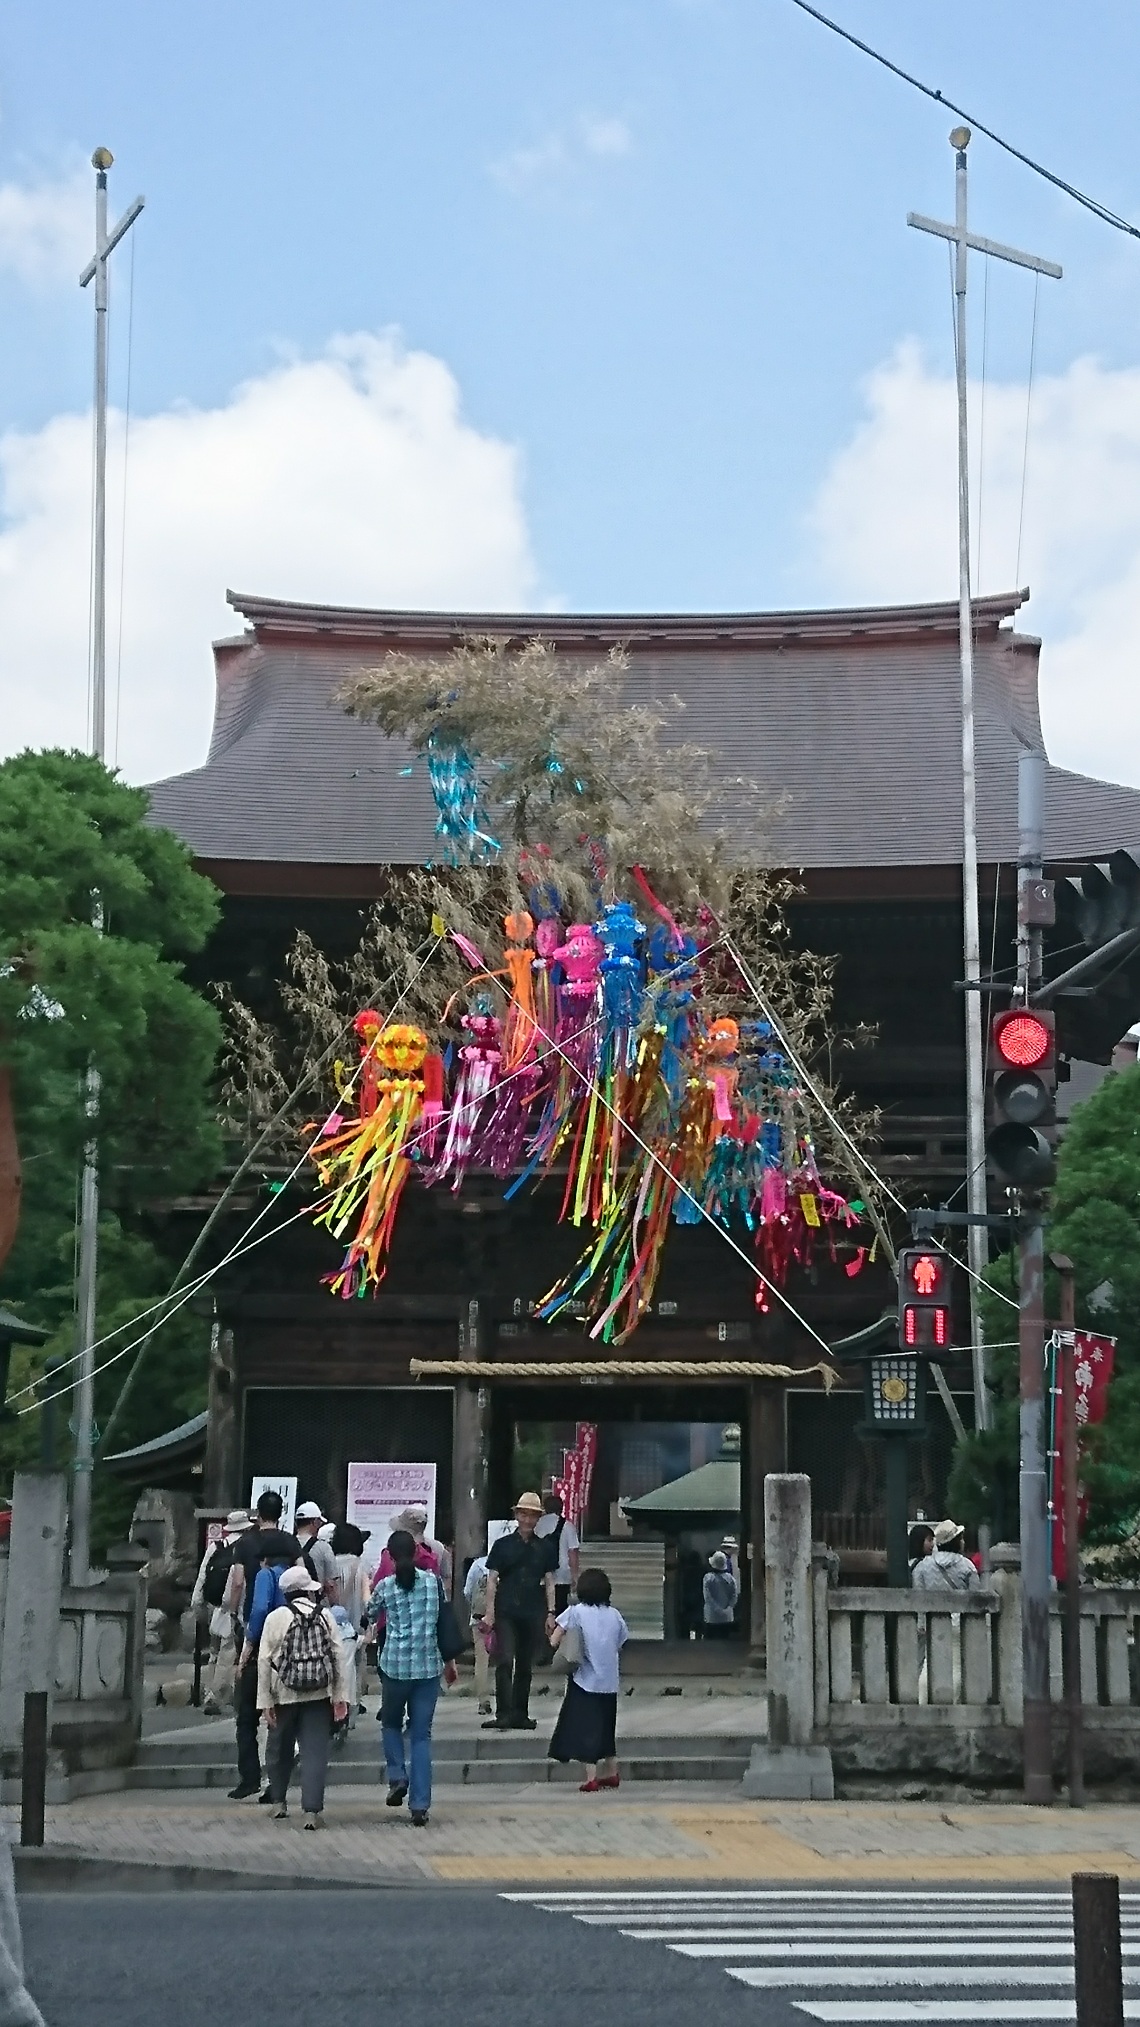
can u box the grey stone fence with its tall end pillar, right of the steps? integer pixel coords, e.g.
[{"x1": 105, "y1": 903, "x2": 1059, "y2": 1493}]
[{"x1": 751, "y1": 1476, "x2": 1140, "y2": 1794}]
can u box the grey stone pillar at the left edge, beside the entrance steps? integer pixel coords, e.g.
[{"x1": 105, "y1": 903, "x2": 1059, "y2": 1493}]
[{"x1": 0, "y1": 1472, "x2": 67, "y2": 1766}]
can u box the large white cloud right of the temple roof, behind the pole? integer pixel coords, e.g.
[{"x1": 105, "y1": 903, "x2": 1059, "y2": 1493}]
[{"x1": 809, "y1": 345, "x2": 1140, "y2": 786}]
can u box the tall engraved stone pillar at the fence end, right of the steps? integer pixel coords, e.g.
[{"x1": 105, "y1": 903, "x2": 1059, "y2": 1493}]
[{"x1": 765, "y1": 1472, "x2": 815, "y2": 1745}]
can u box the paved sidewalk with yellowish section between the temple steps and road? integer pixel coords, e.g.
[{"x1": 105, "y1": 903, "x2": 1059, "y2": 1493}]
[{"x1": 2, "y1": 1782, "x2": 1140, "y2": 1887}]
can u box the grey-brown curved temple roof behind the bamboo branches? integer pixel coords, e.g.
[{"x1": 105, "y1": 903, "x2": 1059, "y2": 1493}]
[{"x1": 150, "y1": 592, "x2": 1140, "y2": 868}]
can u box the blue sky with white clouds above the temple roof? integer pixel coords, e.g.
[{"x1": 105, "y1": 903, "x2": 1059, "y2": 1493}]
[{"x1": 0, "y1": 0, "x2": 1140, "y2": 784}]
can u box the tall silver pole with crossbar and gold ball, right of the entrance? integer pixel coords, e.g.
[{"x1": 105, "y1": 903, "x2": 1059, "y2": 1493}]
[{"x1": 907, "y1": 138, "x2": 1061, "y2": 1429}]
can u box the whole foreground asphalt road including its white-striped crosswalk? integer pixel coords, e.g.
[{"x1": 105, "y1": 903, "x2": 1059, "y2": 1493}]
[{"x1": 20, "y1": 1851, "x2": 1103, "y2": 2027}]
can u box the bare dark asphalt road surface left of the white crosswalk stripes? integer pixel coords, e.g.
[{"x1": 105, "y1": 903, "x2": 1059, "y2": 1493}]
[{"x1": 20, "y1": 1887, "x2": 805, "y2": 2027}]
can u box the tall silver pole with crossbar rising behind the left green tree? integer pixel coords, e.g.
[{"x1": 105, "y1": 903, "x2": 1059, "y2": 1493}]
[{"x1": 71, "y1": 148, "x2": 144, "y2": 1583}]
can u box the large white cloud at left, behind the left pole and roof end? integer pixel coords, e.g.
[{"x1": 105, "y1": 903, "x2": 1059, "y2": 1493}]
[{"x1": 0, "y1": 334, "x2": 536, "y2": 780}]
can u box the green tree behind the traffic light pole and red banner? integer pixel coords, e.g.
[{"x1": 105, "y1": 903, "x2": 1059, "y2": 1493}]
[{"x1": 951, "y1": 1066, "x2": 1140, "y2": 1543}]
